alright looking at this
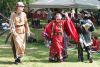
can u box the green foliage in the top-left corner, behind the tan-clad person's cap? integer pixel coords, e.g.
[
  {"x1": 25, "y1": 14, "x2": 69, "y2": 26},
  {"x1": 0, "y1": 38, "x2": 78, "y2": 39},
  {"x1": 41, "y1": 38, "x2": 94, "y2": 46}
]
[{"x1": 0, "y1": 0, "x2": 35, "y2": 16}]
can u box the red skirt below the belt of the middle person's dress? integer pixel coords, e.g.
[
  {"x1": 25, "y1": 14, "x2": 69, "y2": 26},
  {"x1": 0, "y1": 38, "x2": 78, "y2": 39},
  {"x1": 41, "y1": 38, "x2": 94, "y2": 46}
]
[{"x1": 50, "y1": 35, "x2": 64, "y2": 58}]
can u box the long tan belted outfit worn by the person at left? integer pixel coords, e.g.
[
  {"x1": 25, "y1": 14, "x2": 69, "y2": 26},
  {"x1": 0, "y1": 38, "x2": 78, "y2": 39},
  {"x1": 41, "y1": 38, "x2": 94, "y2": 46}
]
[{"x1": 11, "y1": 12, "x2": 30, "y2": 58}]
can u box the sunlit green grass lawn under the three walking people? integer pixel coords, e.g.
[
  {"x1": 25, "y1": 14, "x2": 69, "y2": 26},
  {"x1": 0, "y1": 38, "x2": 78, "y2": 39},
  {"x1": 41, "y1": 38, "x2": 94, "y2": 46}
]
[{"x1": 0, "y1": 23, "x2": 100, "y2": 67}]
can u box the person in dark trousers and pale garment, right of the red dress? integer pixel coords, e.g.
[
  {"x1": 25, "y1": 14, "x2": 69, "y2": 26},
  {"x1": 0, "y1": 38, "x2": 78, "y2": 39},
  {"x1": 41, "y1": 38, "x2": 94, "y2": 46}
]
[{"x1": 78, "y1": 11, "x2": 94, "y2": 63}]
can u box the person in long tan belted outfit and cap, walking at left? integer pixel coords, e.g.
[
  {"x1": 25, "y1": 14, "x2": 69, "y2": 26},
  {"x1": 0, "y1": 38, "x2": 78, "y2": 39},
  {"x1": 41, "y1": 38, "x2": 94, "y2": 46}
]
[{"x1": 10, "y1": 2, "x2": 30, "y2": 64}]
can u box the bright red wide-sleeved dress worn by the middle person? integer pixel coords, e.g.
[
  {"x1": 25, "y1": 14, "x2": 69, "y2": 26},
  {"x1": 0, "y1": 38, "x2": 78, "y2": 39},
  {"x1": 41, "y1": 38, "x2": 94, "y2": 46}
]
[{"x1": 43, "y1": 20, "x2": 78, "y2": 61}]
